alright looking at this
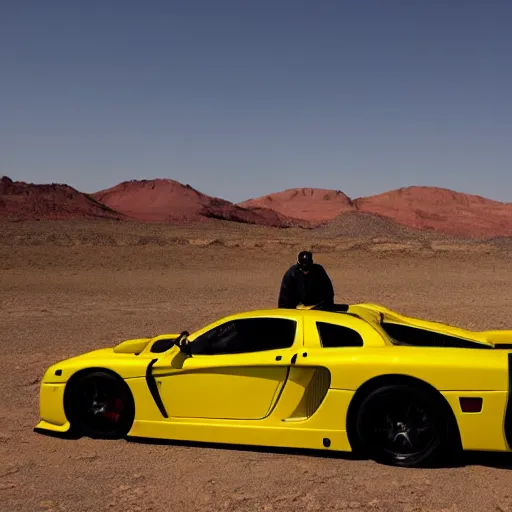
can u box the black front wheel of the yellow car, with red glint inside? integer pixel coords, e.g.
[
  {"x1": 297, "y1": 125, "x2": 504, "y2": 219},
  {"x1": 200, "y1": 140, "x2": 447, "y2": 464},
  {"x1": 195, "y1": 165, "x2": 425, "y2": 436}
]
[{"x1": 64, "y1": 371, "x2": 135, "y2": 439}]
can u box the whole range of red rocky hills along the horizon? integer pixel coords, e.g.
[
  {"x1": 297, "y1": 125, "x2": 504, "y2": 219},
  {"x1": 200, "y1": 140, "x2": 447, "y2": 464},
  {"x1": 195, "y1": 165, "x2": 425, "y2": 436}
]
[{"x1": 0, "y1": 177, "x2": 512, "y2": 238}]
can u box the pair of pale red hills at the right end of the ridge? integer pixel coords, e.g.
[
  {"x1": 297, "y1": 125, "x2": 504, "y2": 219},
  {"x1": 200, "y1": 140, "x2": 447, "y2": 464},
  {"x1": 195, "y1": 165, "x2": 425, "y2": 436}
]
[{"x1": 240, "y1": 186, "x2": 512, "y2": 238}]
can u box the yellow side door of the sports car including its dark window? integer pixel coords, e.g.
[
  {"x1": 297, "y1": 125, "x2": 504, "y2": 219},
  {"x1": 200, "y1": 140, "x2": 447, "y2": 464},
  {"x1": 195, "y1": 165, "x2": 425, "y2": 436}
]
[{"x1": 152, "y1": 317, "x2": 303, "y2": 420}]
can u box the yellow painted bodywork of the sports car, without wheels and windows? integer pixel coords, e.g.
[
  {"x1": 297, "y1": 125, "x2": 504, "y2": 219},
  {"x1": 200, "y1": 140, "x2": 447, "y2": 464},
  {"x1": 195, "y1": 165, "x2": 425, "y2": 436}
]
[{"x1": 36, "y1": 304, "x2": 512, "y2": 460}]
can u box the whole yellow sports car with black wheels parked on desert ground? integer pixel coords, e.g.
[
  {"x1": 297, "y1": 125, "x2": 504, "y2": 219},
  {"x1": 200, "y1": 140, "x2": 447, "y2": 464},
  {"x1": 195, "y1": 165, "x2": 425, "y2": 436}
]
[{"x1": 36, "y1": 304, "x2": 512, "y2": 466}]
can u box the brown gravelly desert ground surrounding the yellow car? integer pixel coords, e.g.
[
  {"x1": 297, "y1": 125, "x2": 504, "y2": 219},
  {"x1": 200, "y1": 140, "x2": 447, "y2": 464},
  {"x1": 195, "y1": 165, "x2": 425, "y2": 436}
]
[{"x1": 0, "y1": 221, "x2": 512, "y2": 512}]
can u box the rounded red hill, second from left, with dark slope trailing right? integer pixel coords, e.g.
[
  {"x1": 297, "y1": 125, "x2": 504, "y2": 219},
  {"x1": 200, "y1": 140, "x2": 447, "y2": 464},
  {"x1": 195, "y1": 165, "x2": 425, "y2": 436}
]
[{"x1": 92, "y1": 179, "x2": 299, "y2": 227}]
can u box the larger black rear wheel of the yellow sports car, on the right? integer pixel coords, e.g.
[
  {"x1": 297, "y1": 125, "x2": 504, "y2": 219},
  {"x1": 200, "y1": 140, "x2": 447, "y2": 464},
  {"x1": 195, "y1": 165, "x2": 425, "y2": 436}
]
[{"x1": 353, "y1": 384, "x2": 451, "y2": 467}]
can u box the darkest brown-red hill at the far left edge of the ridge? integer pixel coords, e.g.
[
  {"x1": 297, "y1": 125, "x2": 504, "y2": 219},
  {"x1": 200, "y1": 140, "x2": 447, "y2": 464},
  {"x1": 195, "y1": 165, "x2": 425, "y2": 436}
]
[{"x1": 0, "y1": 176, "x2": 123, "y2": 220}]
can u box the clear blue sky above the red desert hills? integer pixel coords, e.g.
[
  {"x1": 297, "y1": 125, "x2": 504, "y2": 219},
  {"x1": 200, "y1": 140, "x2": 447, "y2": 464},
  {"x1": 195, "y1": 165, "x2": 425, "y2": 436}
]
[{"x1": 0, "y1": 0, "x2": 512, "y2": 202}]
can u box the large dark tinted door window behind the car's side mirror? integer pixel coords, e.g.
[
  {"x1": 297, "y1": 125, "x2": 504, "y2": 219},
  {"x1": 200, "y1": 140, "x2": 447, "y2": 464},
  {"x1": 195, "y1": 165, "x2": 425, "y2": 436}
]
[{"x1": 190, "y1": 318, "x2": 297, "y2": 355}]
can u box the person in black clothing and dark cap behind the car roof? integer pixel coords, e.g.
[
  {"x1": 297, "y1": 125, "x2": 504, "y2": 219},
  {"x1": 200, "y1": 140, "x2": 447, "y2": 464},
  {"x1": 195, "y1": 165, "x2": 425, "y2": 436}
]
[{"x1": 278, "y1": 251, "x2": 334, "y2": 309}]
